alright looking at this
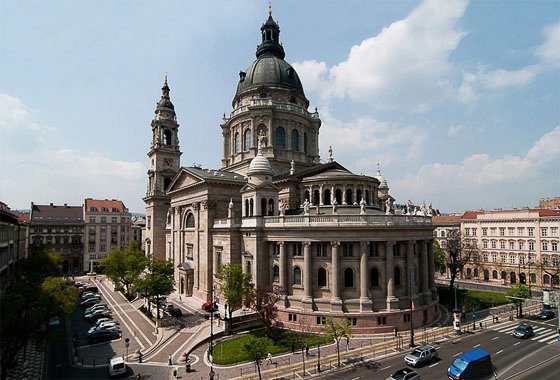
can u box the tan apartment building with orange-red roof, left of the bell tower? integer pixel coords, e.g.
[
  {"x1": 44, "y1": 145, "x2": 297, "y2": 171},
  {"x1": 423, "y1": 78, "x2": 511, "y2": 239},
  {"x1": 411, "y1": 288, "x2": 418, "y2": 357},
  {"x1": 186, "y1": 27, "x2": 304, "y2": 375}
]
[{"x1": 83, "y1": 198, "x2": 132, "y2": 272}]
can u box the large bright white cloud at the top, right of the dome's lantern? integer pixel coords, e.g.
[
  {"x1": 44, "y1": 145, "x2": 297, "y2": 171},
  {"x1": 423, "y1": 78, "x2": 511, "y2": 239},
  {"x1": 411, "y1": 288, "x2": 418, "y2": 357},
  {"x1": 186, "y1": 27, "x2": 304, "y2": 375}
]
[{"x1": 294, "y1": 0, "x2": 468, "y2": 112}]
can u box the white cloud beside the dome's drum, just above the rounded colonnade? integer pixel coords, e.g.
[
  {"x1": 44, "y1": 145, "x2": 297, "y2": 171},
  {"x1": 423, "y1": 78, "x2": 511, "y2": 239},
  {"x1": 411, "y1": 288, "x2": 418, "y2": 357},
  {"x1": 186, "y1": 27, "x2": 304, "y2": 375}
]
[{"x1": 320, "y1": 108, "x2": 427, "y2": 173}]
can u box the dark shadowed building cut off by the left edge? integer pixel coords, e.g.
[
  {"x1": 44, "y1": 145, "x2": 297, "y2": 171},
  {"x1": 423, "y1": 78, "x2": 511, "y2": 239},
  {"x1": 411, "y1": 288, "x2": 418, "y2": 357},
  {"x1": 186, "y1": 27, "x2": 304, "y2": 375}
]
[{"x1": 0, "y1": 202, "x2": 27, "y2": 297}]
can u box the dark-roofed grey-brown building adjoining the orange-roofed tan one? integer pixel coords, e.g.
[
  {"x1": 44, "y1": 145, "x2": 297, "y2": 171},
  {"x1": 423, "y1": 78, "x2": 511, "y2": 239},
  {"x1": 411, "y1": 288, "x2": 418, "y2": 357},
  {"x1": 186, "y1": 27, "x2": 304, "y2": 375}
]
[{"x1": 28, "y1": 202, "x2": 84, "y2": 274}]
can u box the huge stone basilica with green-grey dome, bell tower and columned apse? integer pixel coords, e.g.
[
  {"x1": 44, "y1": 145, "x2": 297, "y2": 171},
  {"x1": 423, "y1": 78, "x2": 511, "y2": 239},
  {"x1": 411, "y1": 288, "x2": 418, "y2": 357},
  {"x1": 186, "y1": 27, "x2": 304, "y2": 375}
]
[{"x1": 143, "y1": 11, "x2": 438, "y2": 334}]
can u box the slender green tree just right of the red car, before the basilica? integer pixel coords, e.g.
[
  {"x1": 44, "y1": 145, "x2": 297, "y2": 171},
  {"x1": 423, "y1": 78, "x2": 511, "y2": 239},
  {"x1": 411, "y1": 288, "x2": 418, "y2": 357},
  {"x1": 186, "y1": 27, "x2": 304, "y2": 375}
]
[{"x1": 216, "y1": 264, "x2": 253, "y2": 333}]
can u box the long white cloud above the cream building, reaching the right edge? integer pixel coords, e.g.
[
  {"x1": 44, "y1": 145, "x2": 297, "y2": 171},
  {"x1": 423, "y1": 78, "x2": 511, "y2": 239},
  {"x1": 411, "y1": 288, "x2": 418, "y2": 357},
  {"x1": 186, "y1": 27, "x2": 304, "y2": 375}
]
[{"x1": 394, "y1": 125, "x2": 560, "y2": 209}]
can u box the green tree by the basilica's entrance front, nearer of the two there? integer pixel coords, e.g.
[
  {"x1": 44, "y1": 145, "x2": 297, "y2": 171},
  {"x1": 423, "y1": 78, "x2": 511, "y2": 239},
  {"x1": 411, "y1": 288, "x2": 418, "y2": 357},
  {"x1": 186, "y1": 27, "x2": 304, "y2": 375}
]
[{"x1": 132, "y1": 260, "x2": 173, "y2": 319}]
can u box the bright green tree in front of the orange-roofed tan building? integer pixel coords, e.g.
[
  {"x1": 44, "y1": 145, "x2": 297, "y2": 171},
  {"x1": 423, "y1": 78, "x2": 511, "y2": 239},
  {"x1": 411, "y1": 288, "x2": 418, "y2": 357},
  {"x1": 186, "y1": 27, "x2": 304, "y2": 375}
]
[{"x1": 100, "y1": 241, "x2": 149, "y2": 297}]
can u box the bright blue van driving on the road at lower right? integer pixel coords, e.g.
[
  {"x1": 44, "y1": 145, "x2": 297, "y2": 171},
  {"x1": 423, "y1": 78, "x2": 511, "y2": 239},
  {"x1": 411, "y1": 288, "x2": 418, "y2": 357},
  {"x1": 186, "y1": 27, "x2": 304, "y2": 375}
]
[{"x1": 447, "y1": 348, "x2": 492, "y2": 380}]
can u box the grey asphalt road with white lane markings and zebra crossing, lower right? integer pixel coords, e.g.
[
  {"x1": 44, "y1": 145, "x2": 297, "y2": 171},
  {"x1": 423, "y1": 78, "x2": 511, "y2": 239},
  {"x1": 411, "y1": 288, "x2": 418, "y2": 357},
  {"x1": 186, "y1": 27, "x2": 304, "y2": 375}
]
[{"x1": 324, "y1": 319, "x2": 560, "y2": 380}]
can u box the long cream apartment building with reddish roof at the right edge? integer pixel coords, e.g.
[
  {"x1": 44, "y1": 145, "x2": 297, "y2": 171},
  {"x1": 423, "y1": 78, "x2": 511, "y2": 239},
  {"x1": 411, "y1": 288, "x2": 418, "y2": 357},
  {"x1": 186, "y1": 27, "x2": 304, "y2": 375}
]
[{"x1": 461, "y1": 209, "x2": 560, "y2": 287}]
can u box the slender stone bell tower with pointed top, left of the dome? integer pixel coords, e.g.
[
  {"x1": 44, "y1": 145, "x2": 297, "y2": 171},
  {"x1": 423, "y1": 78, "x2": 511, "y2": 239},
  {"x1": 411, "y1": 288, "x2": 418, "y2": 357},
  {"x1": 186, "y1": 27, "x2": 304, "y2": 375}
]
[{"x1": 143, "y1": 75, "x2": 181, "y2": 259}]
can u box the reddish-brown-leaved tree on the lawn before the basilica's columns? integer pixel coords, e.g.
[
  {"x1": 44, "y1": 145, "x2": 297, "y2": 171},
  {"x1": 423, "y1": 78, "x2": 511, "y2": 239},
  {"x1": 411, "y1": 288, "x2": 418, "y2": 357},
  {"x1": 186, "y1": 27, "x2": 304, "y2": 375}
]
[{"x1": 247, "y1": 286, "x2": 284, "y2": 340}]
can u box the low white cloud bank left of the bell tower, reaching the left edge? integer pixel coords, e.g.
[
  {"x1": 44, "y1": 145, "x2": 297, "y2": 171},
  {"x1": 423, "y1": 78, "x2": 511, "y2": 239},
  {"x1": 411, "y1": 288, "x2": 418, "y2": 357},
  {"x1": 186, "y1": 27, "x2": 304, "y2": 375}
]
[{"x1": 0, "y1": 94, "x2": 146, "y2": 211}]
